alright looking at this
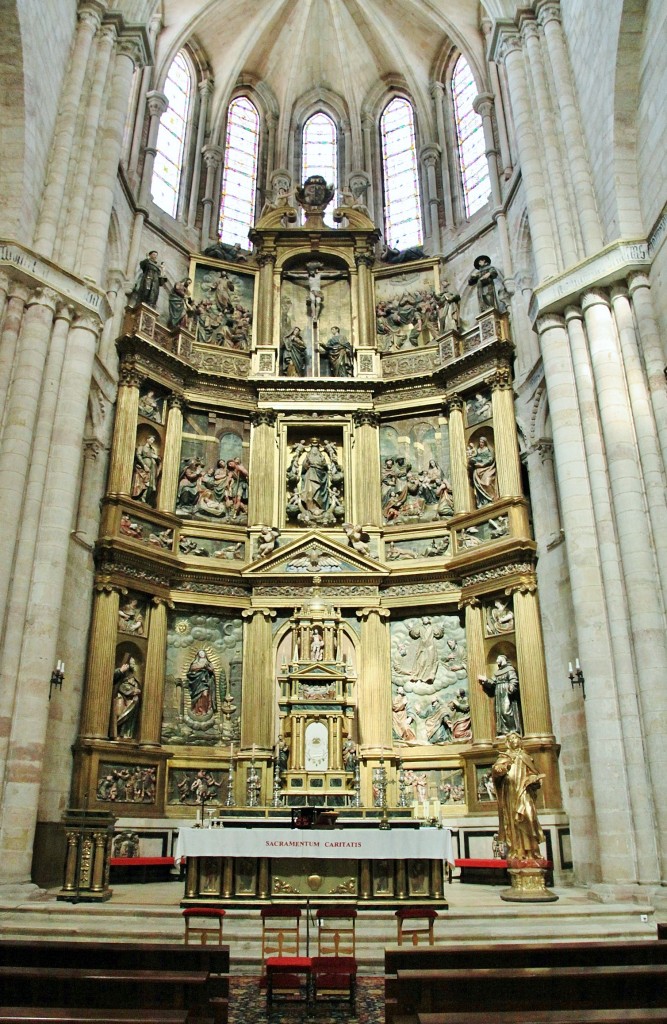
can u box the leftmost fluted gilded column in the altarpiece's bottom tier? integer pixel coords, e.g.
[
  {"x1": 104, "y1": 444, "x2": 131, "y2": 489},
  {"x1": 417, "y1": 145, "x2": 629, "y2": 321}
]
[{"x1": 80, "y1": 577, "x2": 127, "y2": 739}]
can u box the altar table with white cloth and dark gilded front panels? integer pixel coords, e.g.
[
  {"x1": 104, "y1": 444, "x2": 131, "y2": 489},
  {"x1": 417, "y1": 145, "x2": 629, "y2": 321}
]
[{"x1": 174, "y1": 826, "x2": 454, "y2": 907}]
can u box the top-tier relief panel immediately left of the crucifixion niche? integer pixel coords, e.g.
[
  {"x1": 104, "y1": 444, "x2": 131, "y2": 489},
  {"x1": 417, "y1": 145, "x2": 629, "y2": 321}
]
[{"x1": 191, "y1": 260, "x2": 255, "y2": 351}]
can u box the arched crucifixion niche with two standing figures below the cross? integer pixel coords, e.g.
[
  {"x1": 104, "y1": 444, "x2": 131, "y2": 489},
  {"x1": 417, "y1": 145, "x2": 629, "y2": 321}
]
[{"x1": 280, "y1": 253, "x2": 355, "y2": 377}]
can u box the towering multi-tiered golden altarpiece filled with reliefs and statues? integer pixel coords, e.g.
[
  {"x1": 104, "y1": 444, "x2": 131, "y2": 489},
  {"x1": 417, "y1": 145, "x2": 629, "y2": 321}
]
[{"x1": 73, "y1": 189, "x2": 567, "y2": 905}]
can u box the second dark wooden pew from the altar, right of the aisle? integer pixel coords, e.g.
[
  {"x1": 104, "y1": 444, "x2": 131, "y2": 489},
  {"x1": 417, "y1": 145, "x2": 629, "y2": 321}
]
[{"x1": 385, "y1": 964, "x2": 667, "y2": 1021}]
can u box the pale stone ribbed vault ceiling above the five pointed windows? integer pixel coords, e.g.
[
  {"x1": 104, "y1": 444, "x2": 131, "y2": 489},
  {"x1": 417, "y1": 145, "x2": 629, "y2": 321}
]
[{"x1": 157, "y1": 0, "x2": 489, "y2": 141}]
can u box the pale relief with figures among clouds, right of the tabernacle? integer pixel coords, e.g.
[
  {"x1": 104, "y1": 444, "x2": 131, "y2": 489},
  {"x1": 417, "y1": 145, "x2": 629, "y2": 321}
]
[{"x1": 390, "y1": 615, "x2": 472, "y2": 745}]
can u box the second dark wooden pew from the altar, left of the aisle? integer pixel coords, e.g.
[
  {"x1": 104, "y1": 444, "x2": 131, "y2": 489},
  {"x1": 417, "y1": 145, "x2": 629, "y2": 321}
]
[{"x1": 0, "y1": 966, "x2": 223, "y2": 1024}]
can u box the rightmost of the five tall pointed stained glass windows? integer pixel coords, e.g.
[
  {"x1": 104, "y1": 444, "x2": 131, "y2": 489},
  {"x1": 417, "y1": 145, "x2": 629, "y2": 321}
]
[{"x1": 452, "y1": 56, "x2": 491, "y2": 217}]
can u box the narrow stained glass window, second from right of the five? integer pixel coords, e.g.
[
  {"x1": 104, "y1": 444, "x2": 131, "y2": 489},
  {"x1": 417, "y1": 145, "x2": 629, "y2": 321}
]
[{"x1": 380, "y1": 96, "x2": 422, "y2": 249}]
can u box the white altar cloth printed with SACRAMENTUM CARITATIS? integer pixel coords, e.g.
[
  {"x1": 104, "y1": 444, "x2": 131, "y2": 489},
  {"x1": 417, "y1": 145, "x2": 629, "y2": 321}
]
[{"x1": 174, "y1": 828, "x2": 454, "y2": 864}]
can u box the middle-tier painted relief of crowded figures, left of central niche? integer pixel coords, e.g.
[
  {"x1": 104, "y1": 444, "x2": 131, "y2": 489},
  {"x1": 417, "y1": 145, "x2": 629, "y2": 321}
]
[{"x1": 175, "y1": 413, "x2": 248, "y2": 526}]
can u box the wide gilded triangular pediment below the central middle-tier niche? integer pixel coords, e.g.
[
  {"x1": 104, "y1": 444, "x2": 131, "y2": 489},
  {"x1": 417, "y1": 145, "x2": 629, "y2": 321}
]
[{"x1": 243, "y1": 530, "x2": 386, "y2": 579}]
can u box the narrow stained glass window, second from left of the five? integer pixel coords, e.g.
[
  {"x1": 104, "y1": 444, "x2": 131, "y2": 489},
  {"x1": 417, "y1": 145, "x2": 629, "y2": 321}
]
[{"x1": 219, "y1": 96, "x2": 259, "y2": 249}]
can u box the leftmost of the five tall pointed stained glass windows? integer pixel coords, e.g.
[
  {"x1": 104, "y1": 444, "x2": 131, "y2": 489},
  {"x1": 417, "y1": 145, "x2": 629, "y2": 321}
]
[{"x1": 151, "y1": 52, "x2": 193, "y2": 217}]
